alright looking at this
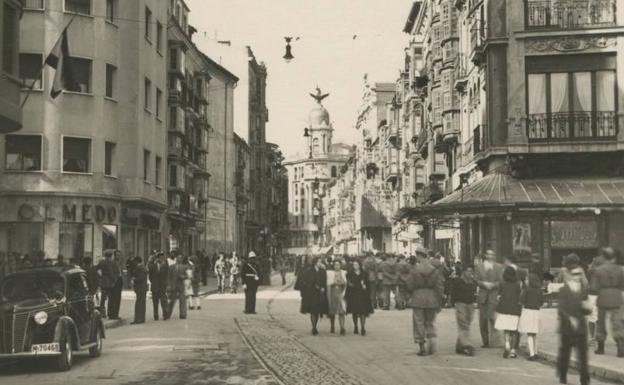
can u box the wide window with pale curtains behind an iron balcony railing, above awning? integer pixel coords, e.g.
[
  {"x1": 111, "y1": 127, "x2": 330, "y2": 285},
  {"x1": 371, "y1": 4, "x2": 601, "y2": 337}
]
[{"x1": 527, "y1": 70, "x2": 617, "y2": 140}]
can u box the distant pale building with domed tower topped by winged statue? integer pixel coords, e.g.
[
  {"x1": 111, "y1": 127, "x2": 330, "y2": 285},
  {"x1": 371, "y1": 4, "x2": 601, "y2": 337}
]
[{"x1": 284, "y1": 89, "x2": 352, "y2": 254}]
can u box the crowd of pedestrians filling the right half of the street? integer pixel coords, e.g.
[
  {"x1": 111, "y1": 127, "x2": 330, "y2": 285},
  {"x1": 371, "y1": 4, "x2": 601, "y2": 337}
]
[{"x1": 295, "y1": 247, "x2": 624, "y2": 385}]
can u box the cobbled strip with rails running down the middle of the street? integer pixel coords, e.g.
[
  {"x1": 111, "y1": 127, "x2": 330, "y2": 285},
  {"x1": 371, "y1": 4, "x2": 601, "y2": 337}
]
[{"x1": 236, "y1": 316, "x2": 363, "y2": 385}]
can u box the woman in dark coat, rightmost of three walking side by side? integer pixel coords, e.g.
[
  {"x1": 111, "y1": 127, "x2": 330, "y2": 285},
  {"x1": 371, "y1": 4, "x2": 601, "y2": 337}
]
[{"x1": 345, "y1": 260, "x2": 373, "y2": 336}]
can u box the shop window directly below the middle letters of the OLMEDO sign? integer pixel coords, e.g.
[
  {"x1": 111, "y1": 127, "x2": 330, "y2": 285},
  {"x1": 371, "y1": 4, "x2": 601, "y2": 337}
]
[{"x1": 59, "y1": 222, "x2": 93, "y2": 263}]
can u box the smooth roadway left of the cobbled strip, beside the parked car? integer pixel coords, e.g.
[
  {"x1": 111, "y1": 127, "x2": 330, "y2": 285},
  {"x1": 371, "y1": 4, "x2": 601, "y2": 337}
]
[{"x1": 0, "y1": 294, "x2": 276, "y2": 385}]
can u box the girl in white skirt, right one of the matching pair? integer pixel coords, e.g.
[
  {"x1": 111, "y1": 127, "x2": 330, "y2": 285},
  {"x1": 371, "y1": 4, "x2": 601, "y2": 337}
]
[{"x1": 518, "y1": 274, "x2": 544, "y2": 361}]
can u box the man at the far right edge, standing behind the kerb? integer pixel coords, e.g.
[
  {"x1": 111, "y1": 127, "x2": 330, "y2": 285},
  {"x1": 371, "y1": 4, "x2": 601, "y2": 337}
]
[{"x1": 591, "y1": 247, "x2": 624, "y2": 357}]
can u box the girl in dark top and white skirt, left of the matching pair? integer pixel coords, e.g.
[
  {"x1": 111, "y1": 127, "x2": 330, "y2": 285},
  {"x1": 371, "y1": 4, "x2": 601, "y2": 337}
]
[{"x1": 494, "y1": 266, "x2": 522, "y2": 358}]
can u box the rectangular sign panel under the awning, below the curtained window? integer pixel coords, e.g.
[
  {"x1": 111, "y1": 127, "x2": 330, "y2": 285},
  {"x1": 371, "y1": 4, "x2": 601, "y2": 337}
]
[{"x1": 550, "y1": 221, "x2": 598, "y2": 248}]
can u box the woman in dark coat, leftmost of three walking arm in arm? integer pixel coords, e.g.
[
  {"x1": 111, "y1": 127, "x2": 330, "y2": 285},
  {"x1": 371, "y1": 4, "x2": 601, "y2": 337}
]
[{"x1": 295, "y1": 255, "x2": 327, "y2": 336}]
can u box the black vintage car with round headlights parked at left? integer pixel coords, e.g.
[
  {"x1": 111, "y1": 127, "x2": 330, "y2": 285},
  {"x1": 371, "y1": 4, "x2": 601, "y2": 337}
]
[{"x1": 0, "y1": 266, "x2": 105, "y2": 370}]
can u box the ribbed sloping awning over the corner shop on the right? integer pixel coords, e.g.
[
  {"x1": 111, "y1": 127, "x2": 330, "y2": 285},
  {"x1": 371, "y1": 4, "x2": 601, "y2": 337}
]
[{"x1": 399, "y1": 173, "x2": 624, "y2": 217}]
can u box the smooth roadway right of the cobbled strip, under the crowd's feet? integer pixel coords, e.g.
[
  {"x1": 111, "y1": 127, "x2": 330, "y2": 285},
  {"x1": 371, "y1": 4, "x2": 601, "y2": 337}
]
[{"x1": 271, "y1": 280, "x2": 616, "y2": 385}]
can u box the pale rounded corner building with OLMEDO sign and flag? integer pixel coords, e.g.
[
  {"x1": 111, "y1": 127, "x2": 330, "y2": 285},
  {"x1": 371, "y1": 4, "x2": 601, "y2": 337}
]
[{"x1": 0, "y1": 0, "x2": 167, "y2": 265}]
